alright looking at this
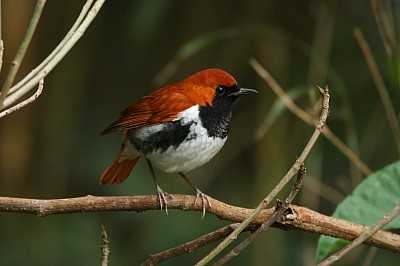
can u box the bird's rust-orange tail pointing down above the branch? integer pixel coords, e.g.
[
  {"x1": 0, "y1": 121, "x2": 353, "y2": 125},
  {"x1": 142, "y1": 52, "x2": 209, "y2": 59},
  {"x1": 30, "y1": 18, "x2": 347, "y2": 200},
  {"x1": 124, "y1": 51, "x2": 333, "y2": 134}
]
[{"x1": 100, "y1": 145, "x2": 140, "y2": 185}]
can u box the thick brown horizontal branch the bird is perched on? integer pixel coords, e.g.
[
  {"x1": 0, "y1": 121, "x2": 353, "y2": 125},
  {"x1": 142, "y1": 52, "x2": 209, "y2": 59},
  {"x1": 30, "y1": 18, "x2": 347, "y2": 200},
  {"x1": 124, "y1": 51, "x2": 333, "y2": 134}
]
[{"x1": 0, "y1": 194, "x2": 400, "y2": 253}]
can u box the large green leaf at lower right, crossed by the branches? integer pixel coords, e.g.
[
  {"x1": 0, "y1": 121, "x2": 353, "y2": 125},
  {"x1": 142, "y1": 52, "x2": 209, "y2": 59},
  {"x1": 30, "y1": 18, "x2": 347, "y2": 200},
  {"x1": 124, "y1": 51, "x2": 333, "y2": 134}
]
[{"x1": 316, "y1": 162, "x2": 400, "y2": 262}]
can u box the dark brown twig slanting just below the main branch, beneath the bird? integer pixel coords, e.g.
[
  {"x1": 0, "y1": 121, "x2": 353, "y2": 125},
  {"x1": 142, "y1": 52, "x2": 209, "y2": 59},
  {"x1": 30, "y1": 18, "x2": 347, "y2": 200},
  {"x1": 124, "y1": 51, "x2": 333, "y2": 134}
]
[{"x1": 142, "y1": 223, "x2": 255, "y2": 266}]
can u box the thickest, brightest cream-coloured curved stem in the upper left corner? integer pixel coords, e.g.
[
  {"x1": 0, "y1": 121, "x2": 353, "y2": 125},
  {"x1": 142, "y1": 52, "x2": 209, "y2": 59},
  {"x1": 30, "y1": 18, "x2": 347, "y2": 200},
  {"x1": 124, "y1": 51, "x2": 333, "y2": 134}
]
[{"x1": 0, "y1": 0, "x2": 105, "y2": 111}]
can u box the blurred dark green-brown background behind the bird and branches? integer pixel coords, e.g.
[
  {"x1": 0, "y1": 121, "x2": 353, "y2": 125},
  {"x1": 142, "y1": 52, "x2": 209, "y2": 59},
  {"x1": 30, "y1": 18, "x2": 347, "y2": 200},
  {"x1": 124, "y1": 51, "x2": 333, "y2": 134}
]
[{"x1": 0, "y1": 0, "x2": 399, "y2": 265}]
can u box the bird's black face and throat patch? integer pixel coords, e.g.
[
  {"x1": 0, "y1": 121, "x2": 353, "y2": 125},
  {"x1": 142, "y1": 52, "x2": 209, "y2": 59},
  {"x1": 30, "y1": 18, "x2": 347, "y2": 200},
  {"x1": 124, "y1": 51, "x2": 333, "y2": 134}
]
[{"x1": 199, "y1": 84, "x2": 245, "y2": 138}]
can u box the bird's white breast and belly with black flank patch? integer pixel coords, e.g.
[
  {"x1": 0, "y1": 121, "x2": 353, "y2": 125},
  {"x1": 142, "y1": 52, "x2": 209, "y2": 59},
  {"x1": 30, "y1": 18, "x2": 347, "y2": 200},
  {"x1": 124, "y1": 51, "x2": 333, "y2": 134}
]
[{"x1": 128, "y1": 106, "x2": 227, "y2": 173}]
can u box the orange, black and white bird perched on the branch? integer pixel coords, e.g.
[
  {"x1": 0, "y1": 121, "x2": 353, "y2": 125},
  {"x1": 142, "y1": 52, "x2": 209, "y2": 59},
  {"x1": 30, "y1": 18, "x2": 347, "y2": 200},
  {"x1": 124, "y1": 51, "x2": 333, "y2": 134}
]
[{"x1": 100, "y1": 68, "x2": 258, "y2": 217}]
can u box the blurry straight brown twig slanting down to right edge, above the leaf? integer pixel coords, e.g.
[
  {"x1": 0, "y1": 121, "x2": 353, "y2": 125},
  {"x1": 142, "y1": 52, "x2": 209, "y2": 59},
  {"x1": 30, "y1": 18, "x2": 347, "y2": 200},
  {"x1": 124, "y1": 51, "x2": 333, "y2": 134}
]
[{"x1": 353, "y1": 28, "x2": 400, "y2": 154}]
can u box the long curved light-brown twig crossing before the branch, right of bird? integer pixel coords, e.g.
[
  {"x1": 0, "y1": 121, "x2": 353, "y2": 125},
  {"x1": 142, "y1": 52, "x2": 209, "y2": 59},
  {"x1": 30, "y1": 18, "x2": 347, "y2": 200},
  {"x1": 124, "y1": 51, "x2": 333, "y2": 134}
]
[{"x1": 196, "y1": 81, "x2": 330, "y2": 265}]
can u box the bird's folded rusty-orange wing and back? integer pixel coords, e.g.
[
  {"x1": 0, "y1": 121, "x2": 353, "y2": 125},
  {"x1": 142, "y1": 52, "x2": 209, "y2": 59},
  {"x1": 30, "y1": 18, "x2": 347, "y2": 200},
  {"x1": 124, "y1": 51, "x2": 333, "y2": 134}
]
[{"x1": 101, "y1": 86, "x2": 196, "y2": 134}]
